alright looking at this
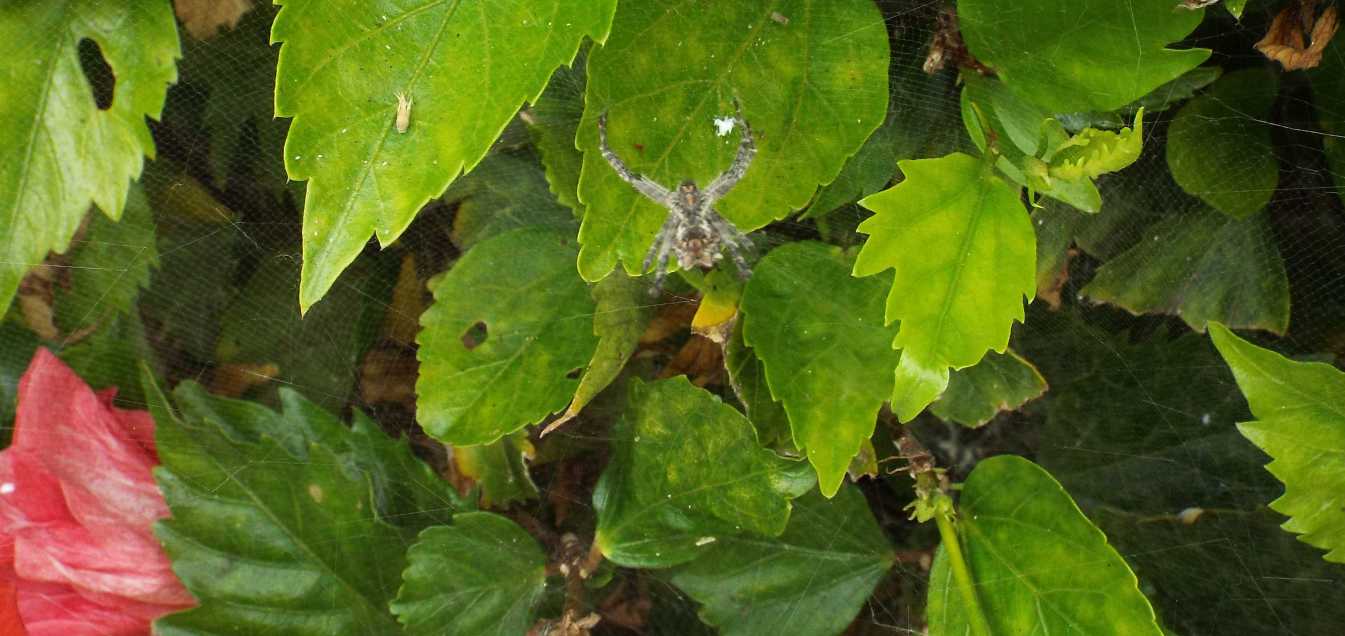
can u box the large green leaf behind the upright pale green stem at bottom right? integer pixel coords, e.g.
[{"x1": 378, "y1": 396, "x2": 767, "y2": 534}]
[{"x1": 927, "y1": 454, "x2": 1162, "y2": 636}]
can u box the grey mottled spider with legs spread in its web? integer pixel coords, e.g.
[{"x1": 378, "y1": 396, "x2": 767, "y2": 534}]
[{"x1": 597, "y1": 100, "x2": 756, "y2": 296}]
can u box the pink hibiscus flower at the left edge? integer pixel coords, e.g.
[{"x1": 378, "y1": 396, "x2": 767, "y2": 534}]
[{"x1": 0, "y1": 348, "x2": 195, "y2": 636}]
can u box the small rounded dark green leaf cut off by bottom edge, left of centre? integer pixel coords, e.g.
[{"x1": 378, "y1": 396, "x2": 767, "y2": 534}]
[{"x1": 391, "y1": 512, "x2": 546, "y2": 636}]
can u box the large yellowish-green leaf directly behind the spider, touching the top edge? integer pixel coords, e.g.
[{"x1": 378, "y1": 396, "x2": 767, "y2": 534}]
[{"x1": 578, "y1": 0, "x2": 889, "y2": 281}]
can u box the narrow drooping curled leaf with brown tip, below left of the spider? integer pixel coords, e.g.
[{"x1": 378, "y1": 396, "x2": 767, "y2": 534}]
[{"x1": 564, "y1": 272, "x2": 654, "y2": 418}]
